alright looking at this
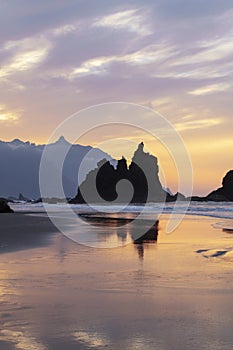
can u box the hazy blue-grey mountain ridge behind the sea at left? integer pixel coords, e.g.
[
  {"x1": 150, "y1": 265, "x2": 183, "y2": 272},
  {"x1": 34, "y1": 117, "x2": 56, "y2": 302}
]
[{"x1": 0, "y1": 136, "x2": 114, "y2": 199}]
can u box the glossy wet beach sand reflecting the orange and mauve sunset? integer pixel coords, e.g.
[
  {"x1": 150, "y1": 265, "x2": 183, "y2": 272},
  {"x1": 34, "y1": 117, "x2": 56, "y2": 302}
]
[{"x1": 0, "y1": 214, "x2": 233, "y2": 350}]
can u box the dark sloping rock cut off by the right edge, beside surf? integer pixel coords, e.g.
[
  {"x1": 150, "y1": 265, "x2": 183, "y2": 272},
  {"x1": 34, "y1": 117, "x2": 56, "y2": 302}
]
[{"x1": 191, "y1": 170, "x2": 233, "y2": 202}]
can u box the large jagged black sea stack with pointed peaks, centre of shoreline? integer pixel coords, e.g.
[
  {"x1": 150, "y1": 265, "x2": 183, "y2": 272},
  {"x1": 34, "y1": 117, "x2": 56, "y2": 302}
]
[{"x1": 70, "y1": 143, "x2": 171, "y2": 203}]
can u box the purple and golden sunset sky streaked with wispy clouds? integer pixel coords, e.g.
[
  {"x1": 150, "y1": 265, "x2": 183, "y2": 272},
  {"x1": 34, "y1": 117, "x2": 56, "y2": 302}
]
[{"x1": 0, "y1": 0, "x2": 233, "y2": 195}]
